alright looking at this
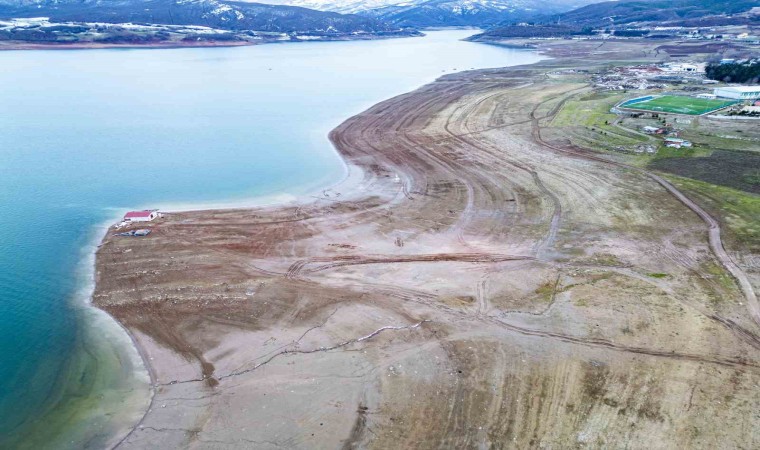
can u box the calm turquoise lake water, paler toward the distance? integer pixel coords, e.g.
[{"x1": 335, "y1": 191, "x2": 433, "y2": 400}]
[{"x1": 0, "y1": 31, "x2": 540, "y2": 448}]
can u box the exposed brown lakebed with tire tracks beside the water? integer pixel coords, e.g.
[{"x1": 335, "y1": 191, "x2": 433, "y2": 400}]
[{"x1": 94, "y1": 43, "x2": 760, "y2": 449}]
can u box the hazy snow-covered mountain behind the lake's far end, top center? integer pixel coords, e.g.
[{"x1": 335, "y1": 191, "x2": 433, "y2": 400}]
[{"x1": 252, "y1": 0, "x2": 594, "y2": 28}]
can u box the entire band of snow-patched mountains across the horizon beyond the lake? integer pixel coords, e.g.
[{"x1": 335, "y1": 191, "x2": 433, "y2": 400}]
[{"x1": 0, "y1": 0, "x2": 760, "y2": 42}]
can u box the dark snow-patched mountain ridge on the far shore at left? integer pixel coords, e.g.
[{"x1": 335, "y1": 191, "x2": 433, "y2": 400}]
[{"x1": 0, "y1": 0, "x2": 410, "y2": 35}]
